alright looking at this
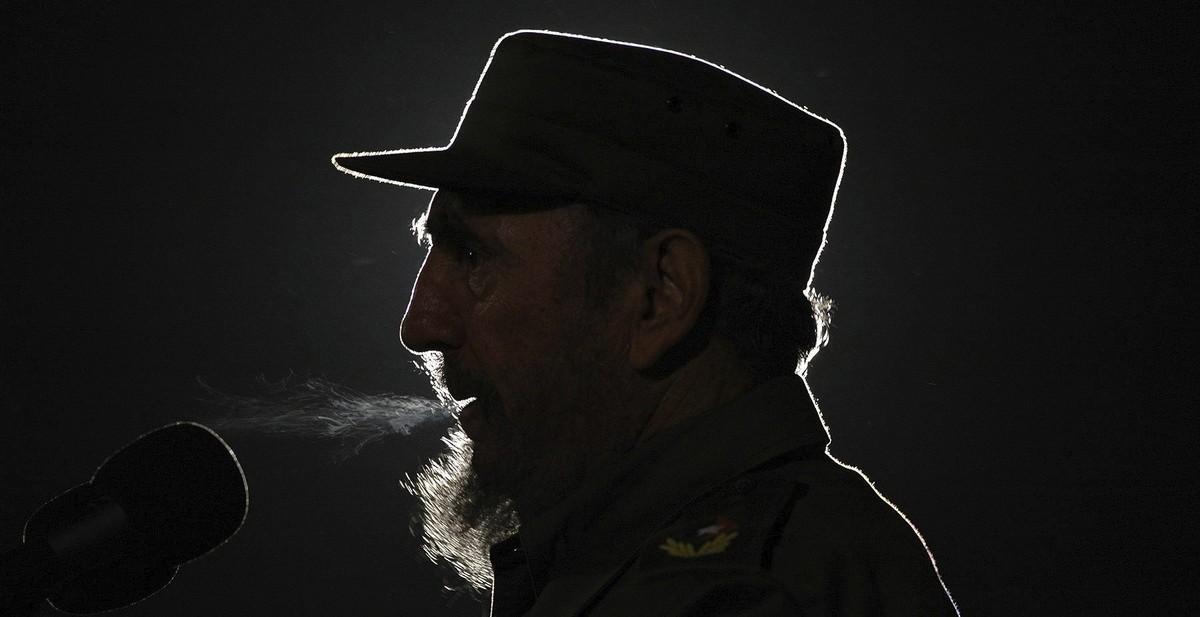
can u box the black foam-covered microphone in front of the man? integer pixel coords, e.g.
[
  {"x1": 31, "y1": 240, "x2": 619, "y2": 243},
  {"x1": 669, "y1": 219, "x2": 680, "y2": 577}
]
[{"x1": 0, "y1": 423, "x2": 250, "y2": 616}]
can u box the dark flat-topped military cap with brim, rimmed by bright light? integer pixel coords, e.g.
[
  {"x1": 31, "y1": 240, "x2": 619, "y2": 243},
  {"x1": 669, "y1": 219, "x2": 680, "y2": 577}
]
[{"x1": 334, "y1": 30, "x2": 846, "y2": 282}]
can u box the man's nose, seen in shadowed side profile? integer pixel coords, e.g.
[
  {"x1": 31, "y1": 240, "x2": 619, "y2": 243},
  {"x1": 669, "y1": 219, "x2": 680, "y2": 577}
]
[{"x1": 400, "y1": 251, "x2": 463, "y2": 353}]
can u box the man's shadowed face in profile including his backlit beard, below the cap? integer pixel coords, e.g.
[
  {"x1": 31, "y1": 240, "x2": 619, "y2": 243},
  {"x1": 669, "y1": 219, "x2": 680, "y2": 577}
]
[{"x1": 401, "y1": 191, "x2": 636, "y2": 587}]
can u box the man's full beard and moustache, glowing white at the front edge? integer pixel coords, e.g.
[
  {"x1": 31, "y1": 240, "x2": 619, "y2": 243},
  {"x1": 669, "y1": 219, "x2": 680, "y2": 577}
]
[{"x1": 406, "y1": 314, "x2": 640, "y2": 592}]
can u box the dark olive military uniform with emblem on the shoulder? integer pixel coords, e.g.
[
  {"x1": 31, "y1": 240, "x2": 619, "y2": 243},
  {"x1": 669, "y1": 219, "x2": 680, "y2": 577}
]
[{"x1": 485, "y1": 376, "x2": 955, "y2": 617}]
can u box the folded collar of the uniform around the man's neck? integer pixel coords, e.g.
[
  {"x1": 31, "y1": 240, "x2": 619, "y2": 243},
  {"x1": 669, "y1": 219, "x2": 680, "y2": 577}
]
[{"x1": 501, "y1": 375, "x2": 829, "y2": 589}]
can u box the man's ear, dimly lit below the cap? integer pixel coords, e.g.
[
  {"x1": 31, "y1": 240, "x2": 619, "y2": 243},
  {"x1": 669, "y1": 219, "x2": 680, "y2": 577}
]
[{"x1": 629, "y1": 229, "x2": 712, "y2": 371}]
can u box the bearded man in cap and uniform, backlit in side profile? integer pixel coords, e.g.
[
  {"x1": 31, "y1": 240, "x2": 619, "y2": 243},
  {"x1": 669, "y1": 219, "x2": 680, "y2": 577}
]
[{"x1": 334, "y1": 31, "x2": 956, "y2": 617}]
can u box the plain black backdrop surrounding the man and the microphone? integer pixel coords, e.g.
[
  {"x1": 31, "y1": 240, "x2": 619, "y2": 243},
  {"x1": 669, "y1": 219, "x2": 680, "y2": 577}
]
[{"x1": 0, "y1": 0, "x2": 1200, "y2": 617}]
